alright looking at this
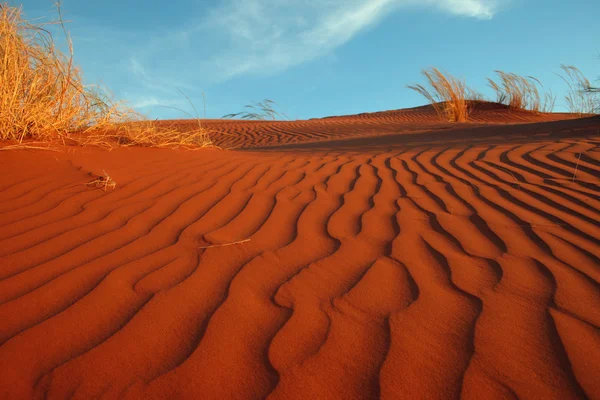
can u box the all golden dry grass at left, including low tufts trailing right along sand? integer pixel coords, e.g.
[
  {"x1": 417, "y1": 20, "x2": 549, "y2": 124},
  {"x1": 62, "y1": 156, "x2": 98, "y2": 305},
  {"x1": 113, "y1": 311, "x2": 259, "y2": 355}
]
[{"x1": 0, "y1": 2, "x2": 210, "y2": 146}]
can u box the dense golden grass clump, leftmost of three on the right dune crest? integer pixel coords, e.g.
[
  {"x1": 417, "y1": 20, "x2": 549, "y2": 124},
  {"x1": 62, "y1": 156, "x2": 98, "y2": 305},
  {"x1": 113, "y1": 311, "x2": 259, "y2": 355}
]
[{"x1": 407, "y1": 68, "x2": 479, "y2": 122}]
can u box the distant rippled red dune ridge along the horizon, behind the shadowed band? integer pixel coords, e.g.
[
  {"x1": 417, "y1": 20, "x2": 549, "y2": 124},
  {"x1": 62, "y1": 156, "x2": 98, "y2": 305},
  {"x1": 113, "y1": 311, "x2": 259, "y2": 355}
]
[{"x1": 159, "y1": 102, "x2": 574, "y2": 149}]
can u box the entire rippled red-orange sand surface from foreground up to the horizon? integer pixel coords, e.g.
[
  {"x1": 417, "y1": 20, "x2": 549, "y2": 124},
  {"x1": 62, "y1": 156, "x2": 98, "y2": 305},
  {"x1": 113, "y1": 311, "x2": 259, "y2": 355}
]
[{"x1": 0, "y1": 108, "x2": 600, "y2": 399}]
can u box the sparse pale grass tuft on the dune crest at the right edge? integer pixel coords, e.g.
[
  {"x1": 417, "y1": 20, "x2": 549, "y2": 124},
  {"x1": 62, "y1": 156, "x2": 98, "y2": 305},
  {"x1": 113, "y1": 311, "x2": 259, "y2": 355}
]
[{"x1": 559, "y1": 64, "x2": 600, "y2": 115}]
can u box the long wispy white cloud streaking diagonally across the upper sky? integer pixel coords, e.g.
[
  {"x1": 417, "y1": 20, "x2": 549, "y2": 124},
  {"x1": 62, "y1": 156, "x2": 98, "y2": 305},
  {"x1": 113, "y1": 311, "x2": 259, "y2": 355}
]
[{"x1": 72, "y1": 0, "x2": 511, "y2": 114}]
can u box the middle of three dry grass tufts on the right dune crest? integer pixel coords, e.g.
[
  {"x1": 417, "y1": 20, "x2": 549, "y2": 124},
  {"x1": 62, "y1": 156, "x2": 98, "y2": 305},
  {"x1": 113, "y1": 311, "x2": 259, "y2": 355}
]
[{"x1": 488, "y1": 71, "x2": 555, "y2": 112}]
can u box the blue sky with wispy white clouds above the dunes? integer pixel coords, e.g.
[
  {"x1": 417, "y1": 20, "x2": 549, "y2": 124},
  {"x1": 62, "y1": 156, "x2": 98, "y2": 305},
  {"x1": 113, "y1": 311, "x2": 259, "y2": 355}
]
[{"x1": 17, "y1": 0, "x2": 600, "y2": 119}]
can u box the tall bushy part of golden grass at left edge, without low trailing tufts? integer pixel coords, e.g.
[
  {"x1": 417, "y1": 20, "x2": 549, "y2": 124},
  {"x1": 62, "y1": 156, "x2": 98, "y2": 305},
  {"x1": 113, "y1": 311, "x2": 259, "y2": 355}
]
[{"x1": 0, "y1": 3, "x2": 114, "y2": 141}]
